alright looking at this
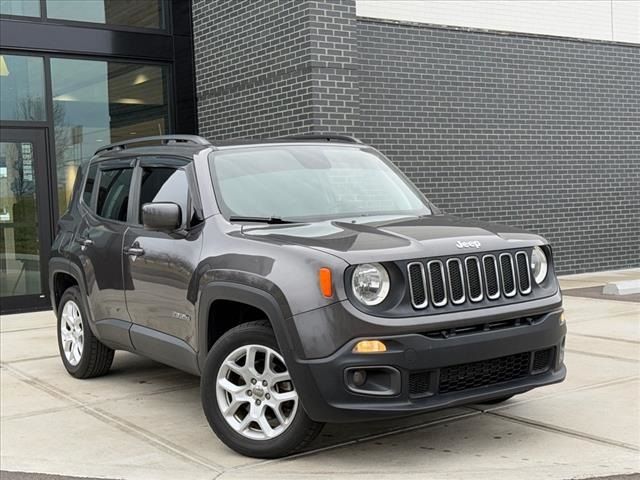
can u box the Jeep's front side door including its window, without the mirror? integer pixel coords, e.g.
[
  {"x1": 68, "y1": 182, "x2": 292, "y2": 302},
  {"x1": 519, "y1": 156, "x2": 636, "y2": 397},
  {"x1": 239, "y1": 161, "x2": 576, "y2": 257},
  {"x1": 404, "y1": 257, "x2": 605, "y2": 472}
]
[{"x1": 124, "y1": 157, "x2": 202, "y2": 354}]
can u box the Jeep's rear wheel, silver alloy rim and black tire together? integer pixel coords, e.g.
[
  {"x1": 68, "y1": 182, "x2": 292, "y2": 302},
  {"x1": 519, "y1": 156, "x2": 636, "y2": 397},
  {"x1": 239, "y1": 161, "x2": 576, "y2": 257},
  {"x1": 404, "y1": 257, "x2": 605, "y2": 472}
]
[{"x1": 58, "y1": 287, "x2": 114, "y2": 378}]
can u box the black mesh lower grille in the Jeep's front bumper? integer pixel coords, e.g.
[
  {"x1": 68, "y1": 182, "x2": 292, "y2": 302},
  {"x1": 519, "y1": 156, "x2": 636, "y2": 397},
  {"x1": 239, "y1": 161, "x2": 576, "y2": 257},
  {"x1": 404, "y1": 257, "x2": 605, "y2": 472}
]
[{"x1": 409, "y1": 348, "x2": 554, "y2": 397}]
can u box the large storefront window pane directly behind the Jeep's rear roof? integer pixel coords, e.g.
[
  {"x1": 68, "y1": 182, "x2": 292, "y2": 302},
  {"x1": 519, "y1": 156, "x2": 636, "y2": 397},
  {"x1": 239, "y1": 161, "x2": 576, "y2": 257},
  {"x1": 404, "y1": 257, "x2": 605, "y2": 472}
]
[{"x1": 51, "y1": 58, "x2": 169, "y2": 213}]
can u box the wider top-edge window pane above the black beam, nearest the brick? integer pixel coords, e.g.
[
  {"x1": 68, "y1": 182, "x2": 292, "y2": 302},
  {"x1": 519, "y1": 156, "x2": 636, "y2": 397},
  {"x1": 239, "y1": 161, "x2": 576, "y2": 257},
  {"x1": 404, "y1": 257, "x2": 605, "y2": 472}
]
[{"x1": 47, "y1": 0, "x2": 165, "y2": 28}]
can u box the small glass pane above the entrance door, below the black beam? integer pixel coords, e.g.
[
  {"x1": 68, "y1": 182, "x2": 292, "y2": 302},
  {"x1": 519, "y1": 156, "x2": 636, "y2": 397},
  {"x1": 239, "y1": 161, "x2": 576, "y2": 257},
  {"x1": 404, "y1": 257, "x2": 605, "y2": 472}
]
[{"x1": 0, "y1": 54, "x2": 46, "y2": 121}]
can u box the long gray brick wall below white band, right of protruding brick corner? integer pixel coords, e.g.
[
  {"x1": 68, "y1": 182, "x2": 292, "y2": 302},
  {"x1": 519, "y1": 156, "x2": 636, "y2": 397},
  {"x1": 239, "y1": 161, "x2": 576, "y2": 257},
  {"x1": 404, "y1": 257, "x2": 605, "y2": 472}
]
[{"x1": 358, "y1": 19, "x2": 640, "y2": 273}]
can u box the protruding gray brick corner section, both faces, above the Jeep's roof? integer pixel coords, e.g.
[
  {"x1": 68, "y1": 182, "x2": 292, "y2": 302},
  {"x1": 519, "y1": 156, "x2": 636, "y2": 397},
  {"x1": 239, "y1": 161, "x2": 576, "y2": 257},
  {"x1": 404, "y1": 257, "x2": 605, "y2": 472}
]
[{"x1": 193, "y1": 0, "x2": 358, "y2": 139}]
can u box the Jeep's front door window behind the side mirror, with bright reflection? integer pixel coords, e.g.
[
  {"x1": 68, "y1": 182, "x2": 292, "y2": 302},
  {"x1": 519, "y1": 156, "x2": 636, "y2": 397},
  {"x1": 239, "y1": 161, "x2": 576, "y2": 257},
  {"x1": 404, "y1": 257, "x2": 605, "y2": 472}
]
[{"x1": 138, "y1": 167, "x2": 189, "y2": 223}]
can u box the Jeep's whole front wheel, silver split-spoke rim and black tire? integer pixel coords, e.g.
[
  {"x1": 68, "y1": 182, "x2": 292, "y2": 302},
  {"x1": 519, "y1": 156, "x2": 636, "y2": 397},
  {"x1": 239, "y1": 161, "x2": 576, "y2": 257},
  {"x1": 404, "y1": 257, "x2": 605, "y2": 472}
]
[{"x1": 201, "y1": 321, "x2": 322, "y2": 458}]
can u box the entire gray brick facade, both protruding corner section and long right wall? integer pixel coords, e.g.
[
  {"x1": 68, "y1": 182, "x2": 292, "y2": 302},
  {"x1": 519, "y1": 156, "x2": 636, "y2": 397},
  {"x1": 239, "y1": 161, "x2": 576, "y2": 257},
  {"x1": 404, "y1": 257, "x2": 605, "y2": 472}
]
[{"x1": 194, "y1": 0, "x2": 640, "y2": 273}]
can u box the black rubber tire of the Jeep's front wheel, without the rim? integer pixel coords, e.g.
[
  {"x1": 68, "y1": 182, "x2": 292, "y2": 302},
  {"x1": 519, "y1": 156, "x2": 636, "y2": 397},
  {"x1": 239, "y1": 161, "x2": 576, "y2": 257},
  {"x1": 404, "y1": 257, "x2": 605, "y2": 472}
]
[{"x1": 200, "y1": 320, "x2": 323, "y2": 458}]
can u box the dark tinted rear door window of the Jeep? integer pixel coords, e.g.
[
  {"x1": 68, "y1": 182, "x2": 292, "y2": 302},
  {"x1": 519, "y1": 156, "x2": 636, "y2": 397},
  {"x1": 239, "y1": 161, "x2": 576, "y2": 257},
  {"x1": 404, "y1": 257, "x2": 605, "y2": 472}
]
[{"x1": 96, "y1": 168, "x2": 133, "y2": 222}]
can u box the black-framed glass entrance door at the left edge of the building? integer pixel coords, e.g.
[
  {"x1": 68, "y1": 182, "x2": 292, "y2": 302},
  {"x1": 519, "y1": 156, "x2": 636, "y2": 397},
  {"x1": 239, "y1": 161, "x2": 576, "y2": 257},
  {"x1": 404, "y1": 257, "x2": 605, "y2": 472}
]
[{"x1": 0, "y1": 128, "x2": 51, "y2": 313}]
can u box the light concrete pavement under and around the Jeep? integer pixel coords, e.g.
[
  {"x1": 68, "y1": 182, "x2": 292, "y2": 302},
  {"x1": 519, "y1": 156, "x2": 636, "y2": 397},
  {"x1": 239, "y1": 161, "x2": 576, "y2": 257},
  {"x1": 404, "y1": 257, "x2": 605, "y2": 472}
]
[{"x1": 0, "y1": 269, "x2": 640, "y2": 480}]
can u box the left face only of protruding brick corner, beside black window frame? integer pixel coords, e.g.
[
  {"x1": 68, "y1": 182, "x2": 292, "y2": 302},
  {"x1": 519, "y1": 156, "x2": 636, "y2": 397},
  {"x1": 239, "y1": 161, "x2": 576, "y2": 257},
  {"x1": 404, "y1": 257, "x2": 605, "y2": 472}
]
[{"x1": 193, "y1": 0, "x2": 313, "y2": 139}]
